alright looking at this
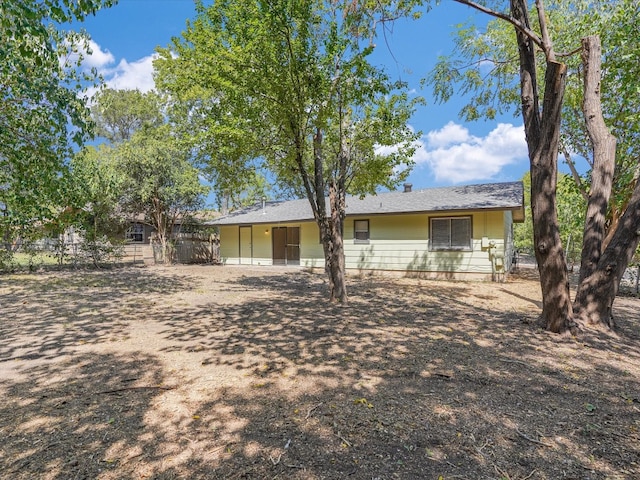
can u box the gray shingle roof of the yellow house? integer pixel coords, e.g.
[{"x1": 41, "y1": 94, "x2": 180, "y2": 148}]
[{"x1": 207, "y1": 182, "x2": 524, "y2": 225}]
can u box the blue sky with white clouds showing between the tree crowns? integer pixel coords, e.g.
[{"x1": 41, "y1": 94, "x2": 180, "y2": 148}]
[{"x1": 74, "y1": 0, "x2": 529, "y2": 195}]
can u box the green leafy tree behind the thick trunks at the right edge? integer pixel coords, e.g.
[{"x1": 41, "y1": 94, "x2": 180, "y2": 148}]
[{"x1": 552, "y1": 0, "x2": 640, "y2": 246}]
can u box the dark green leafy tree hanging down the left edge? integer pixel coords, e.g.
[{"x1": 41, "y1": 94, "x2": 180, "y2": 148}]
[{"x1": 0, "y1": 0, "x2": 114, "y2": 246}]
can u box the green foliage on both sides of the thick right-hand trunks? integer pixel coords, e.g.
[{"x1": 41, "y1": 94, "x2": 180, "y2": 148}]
[{"x1": 425, "y1": 0, "x2": 640, "y2": 199}]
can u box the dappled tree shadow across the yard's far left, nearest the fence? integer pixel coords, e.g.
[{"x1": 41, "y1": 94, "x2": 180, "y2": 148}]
[{"x1": 0, "y1": 268, "x2": 192, "y2": 364}]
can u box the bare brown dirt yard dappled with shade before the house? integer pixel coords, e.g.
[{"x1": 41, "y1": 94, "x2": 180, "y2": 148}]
[{"x1": 0, "y1": 266, "x2": 640, "y2": 480}]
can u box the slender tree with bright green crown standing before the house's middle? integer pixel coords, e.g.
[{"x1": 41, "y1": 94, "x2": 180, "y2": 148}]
[{"x1": 155, "y1": 0, "x2": 416, "y2": 303}]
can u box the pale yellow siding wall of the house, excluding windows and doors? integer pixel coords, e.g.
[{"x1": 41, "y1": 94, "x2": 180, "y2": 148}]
[{"x1": 220, "y1": 211, "x2": 511, "y2": 278}]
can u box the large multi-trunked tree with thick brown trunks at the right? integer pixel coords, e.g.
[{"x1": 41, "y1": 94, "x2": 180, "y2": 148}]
[{"x1": 433, "y1": 0, "x2": 640, "y2": 332}]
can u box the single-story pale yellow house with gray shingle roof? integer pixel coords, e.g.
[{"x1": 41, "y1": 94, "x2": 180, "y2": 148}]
[{"x1": 208, "y1": 182, "x2": 524, "y2": 279}]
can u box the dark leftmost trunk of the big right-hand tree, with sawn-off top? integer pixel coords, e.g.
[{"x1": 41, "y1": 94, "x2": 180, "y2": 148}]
[{"x1": 511, "y1": 0, "x2": 573, "y2": 333}]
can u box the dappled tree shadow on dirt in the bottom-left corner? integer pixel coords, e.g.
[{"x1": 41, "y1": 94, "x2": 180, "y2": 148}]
[{"x1": 0, "y1": 354, "x2": 165, "y2": 479}]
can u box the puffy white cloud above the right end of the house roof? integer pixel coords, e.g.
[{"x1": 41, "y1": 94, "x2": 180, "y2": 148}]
[{"x1": 414, "y1": 122, "x2": 527, "y2": 183}]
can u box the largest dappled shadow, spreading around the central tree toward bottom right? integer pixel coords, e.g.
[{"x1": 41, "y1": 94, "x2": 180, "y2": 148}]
[{"x1": 152, "y1": 274, "x2": 640, "y2": 478}]
